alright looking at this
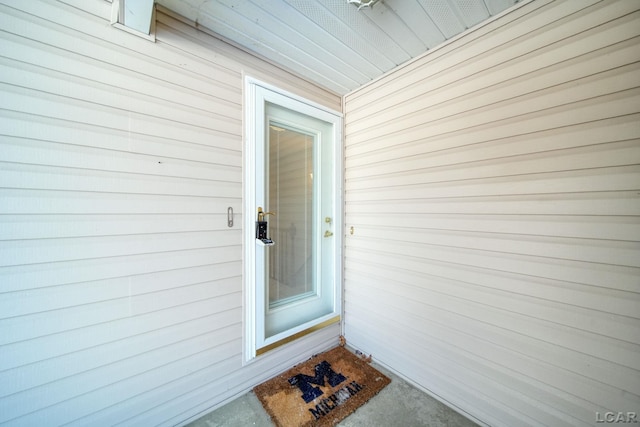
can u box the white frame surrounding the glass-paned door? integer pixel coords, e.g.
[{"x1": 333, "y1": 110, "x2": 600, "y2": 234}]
[{"x1": 243, "y1": 76, "x2": 344, "y2": 363}]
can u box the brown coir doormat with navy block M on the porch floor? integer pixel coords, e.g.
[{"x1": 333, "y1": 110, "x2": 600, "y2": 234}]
[{"x1": 253, "y1": 347, "x2": 391, "y2": 427}]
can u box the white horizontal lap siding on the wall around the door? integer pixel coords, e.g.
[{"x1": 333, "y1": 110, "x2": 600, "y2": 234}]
[{"x1": 0, "y1": 0, "x2": 340, "y2": 426}]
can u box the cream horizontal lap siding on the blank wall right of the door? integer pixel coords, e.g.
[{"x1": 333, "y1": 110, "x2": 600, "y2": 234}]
[{"x1": 345, "y1": 1, "x2": 640, "y2": 426}]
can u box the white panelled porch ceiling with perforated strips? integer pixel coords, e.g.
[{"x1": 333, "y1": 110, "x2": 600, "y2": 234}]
[{"x1": 156, "y1": 0, "x2": 518, "y2": 95}]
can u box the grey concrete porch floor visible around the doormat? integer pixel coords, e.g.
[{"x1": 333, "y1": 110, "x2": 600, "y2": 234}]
[{"x1": 187, "y1": 363, "x2": 477, "y2": 427}]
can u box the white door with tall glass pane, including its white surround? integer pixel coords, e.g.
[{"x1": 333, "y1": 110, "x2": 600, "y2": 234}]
[{"x1": 246, "y1": 78, "x2": 342, "y2": 356}]
